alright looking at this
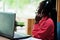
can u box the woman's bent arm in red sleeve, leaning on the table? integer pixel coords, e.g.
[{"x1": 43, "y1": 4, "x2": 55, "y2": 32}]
[{"x1": 32, "y1": 20, "x2": 53, "y2": 38}]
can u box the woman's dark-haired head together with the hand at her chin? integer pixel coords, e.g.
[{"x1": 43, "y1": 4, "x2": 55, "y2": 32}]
[{"x1": 35, "y1": 1, "x2": 56, "y2": 21}]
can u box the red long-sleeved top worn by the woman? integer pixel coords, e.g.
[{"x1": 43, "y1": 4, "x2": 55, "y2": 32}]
[{"x1": 32, "y1": 17, "x2": 54, "y2": 40}]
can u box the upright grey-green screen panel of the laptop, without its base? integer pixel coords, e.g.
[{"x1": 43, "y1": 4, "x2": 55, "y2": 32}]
[{"x1": 0, "y1": 12, "x2": 15, "y2": 38}]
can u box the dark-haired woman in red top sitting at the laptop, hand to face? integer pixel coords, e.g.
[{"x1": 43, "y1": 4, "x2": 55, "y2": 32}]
[{"x1": 32, "y1": 1, "x2": 55, "y2": 40}]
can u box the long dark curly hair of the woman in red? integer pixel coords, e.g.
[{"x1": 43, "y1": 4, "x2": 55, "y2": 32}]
[{"x1": 35, "y1": 1, "x2": 57, "y2": 23}]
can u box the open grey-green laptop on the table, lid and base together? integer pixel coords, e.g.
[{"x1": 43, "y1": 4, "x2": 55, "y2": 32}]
[{"x1": 0, "y1": 12, "x2": 31, "y2": 39}]
